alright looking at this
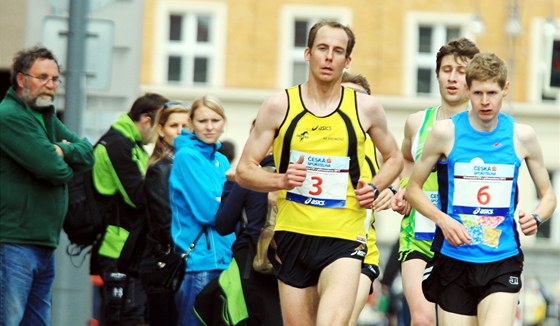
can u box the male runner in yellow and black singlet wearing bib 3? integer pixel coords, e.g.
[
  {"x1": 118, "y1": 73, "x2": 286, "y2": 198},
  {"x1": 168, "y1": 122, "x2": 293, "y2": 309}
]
[{"x1": 236, "y1": 21, "x2": 403, "y2": 325}]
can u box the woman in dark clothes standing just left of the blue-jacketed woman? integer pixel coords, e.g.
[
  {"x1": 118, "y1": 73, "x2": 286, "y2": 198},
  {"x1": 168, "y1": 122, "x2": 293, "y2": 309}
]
[{"x1": 140, "y1": 102, "x2": 189, "y2": 326}]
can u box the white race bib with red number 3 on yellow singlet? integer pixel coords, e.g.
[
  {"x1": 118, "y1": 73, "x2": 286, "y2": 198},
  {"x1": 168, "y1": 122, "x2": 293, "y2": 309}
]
[{"x1": 286, "y1": 151, "x2": 350, "y2": 208}]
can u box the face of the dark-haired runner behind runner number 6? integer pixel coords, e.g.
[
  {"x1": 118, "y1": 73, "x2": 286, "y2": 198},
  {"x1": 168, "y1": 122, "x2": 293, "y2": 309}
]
[{"x1": 437, "y1": 54, "x2": 468, "y2": 105}]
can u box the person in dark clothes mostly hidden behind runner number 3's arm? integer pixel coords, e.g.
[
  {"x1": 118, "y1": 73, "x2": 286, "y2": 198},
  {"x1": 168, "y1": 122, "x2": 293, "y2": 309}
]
[{"x1": 216, "y1": 144, "x2": 282, "y2": 325}]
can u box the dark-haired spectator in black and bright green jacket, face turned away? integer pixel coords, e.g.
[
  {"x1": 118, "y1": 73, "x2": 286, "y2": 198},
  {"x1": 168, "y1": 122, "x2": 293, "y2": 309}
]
[{"x1": 90, "y1": 93, "x2": 168, "y2": 325}]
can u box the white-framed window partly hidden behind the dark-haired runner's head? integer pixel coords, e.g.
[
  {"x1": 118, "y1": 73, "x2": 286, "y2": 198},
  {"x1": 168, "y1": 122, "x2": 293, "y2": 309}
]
[{"x1": 403, "y1": 12, "x2": 474, "y2": 97}]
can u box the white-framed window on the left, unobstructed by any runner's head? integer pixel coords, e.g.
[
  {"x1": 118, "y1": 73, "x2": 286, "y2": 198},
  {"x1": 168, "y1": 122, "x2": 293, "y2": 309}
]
[{"x1": 154, "y1": 2, "x2": 226, "y2": 86}]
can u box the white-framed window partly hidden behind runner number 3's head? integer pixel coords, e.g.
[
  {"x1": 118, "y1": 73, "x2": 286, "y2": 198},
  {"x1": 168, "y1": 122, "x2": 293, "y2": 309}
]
[{"x1": 279, "y1": 5, "x2": 352, "y2": 88}]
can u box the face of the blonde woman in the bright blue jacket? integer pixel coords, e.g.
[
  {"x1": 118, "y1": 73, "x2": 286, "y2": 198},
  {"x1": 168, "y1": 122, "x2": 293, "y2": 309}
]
[{"x1": 191, "y1": 106, "x2": 226, "y2": 144}]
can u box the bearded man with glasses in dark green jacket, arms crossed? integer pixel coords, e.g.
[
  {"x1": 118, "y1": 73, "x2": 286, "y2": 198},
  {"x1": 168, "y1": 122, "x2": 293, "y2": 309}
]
[{"x1": 0, "y1": 47, "x2": 94, "y2": 325}]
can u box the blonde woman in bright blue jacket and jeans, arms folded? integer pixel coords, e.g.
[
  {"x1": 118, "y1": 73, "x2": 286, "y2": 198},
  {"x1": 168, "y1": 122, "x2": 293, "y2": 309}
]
[{"x1": 169, "y1": 96, "x2": 235, "y2": 326}]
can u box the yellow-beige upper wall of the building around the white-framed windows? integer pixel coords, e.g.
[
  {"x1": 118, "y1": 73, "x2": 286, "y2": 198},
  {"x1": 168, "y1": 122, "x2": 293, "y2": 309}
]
[{"x1": 141, "y1": 0, "x2": 560, "y2": 101}]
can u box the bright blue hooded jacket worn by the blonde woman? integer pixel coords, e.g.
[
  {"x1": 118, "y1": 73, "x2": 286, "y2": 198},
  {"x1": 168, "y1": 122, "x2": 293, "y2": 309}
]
[{"x1": 169, "y1": 130, "x2": 235, "y2": 272}]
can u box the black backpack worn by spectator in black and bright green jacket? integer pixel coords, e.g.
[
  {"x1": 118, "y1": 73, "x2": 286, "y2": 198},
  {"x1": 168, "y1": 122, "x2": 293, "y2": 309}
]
[{"x1": 62, "y1": 170, "x2": 106, "y2": 265}]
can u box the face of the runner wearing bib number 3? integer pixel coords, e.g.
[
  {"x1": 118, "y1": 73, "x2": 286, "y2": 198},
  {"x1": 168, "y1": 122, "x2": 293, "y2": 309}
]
[{"x1": 305, "y1": 26, "x2": 351, "y2": 81}]
